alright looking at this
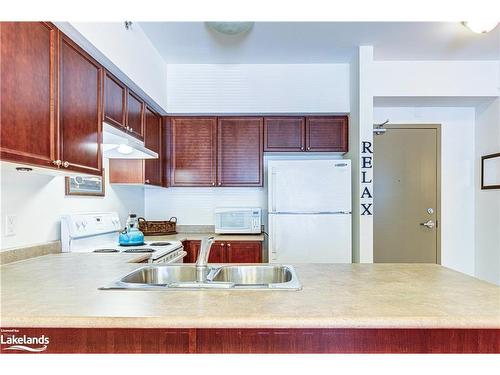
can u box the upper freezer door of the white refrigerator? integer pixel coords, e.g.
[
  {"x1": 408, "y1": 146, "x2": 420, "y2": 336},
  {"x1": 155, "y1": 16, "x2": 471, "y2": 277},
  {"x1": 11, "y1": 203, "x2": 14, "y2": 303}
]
[{"x1": 268, "y1": 159, "x2": 351, "y2": 212}]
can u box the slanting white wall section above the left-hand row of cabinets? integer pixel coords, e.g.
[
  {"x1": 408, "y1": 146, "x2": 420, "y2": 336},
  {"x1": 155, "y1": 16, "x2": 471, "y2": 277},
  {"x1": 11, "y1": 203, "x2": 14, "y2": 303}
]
[{"x1": 56, "y1": 22, "x2": 167, "y2": 110}]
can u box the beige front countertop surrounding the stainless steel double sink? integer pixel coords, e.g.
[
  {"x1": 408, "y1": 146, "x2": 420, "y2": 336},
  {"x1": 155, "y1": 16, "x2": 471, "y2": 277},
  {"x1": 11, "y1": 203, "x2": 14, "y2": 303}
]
[{"x1": 0, "y1": 253, "x2": 500, "y2": 328}]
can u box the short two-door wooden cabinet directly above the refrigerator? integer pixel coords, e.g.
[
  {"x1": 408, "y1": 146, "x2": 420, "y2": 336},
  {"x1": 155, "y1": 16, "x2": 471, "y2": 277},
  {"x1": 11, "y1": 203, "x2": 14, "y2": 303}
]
[{"x1": 264, "y1": 116, "x2": 349, "y2": 153}]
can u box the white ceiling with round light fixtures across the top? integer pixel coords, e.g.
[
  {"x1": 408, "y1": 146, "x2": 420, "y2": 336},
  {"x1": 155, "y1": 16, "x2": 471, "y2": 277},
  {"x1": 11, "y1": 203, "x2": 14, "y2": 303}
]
[{"x1": 139, "y1": 22, "x2": 500, "y2": 64}]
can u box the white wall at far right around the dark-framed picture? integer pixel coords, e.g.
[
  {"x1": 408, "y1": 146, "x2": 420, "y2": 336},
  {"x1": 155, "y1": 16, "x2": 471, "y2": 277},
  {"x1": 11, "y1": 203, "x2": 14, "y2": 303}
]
[{"x1": 474, "y1": 99, "x2": 500, "y2": 285}]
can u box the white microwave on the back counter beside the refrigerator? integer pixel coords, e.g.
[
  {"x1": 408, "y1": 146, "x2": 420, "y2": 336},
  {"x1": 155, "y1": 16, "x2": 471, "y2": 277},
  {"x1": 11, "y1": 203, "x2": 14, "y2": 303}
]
[{"x1": 215, "y1": 207, "x2": 262, "y2": 233}]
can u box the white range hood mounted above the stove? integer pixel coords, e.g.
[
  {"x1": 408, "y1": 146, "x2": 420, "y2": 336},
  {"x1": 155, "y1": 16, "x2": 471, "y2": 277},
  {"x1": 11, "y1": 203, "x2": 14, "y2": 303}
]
[{"x1": 102, "y1": 122, "x2": 158, "y2": 159}]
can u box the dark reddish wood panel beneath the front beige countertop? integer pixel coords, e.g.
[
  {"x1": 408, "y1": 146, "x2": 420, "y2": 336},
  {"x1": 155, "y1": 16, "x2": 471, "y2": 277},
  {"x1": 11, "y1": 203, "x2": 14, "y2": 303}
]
[{"x1": 1, "y1": 328, "x2": 500, "y2": 354}]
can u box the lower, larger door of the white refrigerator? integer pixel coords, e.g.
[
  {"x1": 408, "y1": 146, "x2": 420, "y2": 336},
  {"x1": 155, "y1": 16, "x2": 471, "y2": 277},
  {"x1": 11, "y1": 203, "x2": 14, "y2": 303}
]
[{"x1": 269, "y1": 214, "x2": 352, "y2": 263}]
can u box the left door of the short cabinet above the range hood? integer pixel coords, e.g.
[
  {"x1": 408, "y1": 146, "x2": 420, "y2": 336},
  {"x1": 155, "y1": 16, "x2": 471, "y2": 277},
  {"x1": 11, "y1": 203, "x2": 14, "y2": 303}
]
[{"x1": 104, "y1": 71, "x2": 127, "y2": 128}]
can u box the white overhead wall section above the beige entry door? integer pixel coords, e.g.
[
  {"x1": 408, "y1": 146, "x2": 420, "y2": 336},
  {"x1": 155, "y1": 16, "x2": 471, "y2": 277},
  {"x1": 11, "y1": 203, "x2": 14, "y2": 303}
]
[{"x1": 372, "y1": 61, "x2": 500, "y2": 97}]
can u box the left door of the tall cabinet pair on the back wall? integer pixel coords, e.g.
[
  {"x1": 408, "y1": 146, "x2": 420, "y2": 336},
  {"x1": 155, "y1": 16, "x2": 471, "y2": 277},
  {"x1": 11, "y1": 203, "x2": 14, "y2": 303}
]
[{"x1": 170, "y1": 117, "x2": 217, "y2": 186}]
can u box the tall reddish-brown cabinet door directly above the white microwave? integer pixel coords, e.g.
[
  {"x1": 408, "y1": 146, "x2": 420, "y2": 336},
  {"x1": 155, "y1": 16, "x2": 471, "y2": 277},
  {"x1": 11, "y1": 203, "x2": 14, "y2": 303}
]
[{"x1": 217, "y1": 117, "x2": 263, "y2": 186}]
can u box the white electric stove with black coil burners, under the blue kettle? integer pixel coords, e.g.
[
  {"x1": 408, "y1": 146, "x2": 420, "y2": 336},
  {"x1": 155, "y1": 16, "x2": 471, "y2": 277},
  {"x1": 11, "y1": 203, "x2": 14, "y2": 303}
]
[{"x1": 61, "y1": 212, "x2": 187, "y2": 263}]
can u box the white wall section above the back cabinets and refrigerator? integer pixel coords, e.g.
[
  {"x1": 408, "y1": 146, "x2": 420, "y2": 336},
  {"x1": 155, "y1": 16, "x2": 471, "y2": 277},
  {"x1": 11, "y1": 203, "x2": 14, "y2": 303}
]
[{"x1": 167, "y1": 64, "x2": 349, "y2": 113}]
